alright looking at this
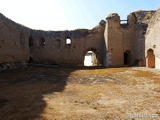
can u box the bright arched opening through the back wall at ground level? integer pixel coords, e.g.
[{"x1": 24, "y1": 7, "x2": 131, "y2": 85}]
[{"x1": 84, "y1": 51, "x2": 98, "y2": 66}]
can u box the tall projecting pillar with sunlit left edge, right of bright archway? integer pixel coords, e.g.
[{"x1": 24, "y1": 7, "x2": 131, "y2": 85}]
[{"x1": 104, "y1": 14, "x2": 123, "y2": 67}]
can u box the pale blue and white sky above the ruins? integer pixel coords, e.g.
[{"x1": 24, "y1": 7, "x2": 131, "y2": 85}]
[{"x1": 0, "y1": 0, "x2": 160, "y2": 30}]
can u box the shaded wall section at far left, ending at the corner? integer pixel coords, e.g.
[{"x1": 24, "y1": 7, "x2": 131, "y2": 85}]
[{"x1": 0, "y1": 14, "x2": 29, "y2": 63}]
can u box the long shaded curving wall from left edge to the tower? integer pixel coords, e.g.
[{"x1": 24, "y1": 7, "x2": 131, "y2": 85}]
[{"x1": 0, "y1": 14, "x2": 105, "y2": 66}]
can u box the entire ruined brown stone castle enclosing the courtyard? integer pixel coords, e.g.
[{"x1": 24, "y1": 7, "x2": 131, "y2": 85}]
[{"x1": 0, "y1": 9, "x2": 160, "y2": 68}]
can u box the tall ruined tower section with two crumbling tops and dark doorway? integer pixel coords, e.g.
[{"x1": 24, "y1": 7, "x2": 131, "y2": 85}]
[{"x1": 104, "y1": 13, "x2": 146, "y2": 67}]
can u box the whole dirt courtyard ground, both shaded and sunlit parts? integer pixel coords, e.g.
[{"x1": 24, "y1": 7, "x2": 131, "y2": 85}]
[{"x1": 0, "y1": 67, "x2": 160, "y2": 120}]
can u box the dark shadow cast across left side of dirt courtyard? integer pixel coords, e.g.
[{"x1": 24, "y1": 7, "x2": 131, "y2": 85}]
[{"x1": 0, "y1": 67, "x2": 77, "y2": 120}]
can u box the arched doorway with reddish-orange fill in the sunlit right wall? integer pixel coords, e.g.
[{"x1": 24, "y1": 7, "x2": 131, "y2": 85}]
[{"x1": 147, "y1": 49, "x2": 155, "y2": 68}]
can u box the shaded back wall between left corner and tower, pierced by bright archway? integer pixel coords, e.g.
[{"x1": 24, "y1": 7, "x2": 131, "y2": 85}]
[{"x1": 30, "y1": 21, "x2": 105, "y2": 66}]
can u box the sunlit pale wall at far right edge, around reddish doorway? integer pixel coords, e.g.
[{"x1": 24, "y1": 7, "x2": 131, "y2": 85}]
[{"x1": 145, "y1": 9, "x2": 160, "y2": 69}]
